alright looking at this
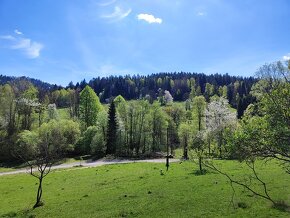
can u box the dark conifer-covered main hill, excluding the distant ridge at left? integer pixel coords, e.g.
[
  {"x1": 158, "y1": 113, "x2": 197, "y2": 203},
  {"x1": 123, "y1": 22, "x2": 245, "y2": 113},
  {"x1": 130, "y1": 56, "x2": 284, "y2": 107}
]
[{"x1": 76, "y1": 72, "x2": 257, "y2": 107}]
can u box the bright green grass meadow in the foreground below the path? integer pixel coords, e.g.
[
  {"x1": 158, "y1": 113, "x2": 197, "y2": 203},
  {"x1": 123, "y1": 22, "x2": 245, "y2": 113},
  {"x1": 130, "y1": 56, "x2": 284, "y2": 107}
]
[{"x1": 0, "y1": 161, "x2": 290, "y2": 217}]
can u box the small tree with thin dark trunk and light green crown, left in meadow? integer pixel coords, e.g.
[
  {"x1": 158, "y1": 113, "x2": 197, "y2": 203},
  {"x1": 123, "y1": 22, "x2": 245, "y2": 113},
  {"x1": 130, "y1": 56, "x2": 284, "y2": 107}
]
[{"x1": 15, "y1": 120, "x2": 79, "y2": 208}]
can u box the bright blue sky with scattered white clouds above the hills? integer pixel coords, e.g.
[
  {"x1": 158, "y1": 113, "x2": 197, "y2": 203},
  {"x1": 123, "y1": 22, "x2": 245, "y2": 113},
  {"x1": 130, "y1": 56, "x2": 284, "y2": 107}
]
[{"x1": 0, "y1": 0, "x2": 290, "y2": 85}]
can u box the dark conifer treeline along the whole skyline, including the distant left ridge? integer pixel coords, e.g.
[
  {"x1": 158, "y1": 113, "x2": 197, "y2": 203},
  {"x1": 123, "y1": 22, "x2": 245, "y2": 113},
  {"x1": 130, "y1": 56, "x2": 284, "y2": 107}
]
[{"x1": 0, "y1": 72, "x2": 257, "y2": 114}]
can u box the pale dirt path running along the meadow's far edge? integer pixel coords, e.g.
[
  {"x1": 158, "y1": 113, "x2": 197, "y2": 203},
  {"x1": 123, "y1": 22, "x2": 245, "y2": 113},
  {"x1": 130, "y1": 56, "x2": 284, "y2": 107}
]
[{"x1": 0, "y1": 158, "x2": 179, "y2": 176}]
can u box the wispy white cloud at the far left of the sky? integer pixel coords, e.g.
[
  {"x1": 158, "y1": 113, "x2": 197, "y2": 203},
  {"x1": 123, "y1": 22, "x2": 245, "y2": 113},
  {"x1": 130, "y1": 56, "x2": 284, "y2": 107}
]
[{"x1": 0, "y1": 30, "x2": 44, "y2": 58}]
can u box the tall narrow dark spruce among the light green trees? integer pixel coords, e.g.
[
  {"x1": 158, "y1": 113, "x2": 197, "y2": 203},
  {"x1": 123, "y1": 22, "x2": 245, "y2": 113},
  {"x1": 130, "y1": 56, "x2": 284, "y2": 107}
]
[{"x1": 106, "y1": 101, "x2": 117, "y2": 154}]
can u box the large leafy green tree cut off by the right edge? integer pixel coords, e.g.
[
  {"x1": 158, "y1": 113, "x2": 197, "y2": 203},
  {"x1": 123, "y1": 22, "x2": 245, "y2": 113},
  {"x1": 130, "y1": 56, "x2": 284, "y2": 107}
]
[{"x1": 231, "y1": 62, "x2": 290, "y2": 167}]
